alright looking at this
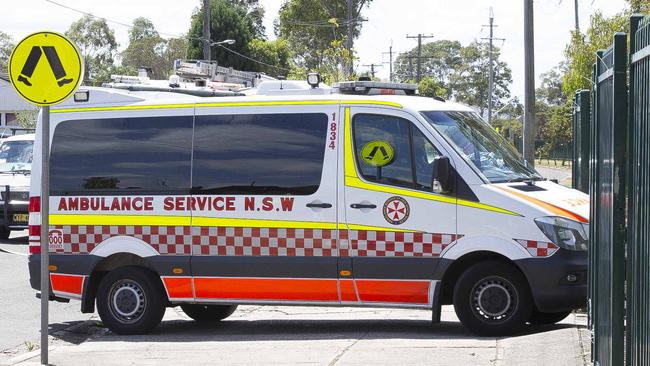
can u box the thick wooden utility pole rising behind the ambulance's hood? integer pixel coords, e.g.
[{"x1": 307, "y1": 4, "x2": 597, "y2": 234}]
[{"x1": 523, "y1": 0, "x2": 535, "y2": 166}]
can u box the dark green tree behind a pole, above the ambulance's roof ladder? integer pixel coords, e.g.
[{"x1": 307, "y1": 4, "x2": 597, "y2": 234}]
[{"x1": 187, "y1": 0, "x2": 259, "y2": 70}]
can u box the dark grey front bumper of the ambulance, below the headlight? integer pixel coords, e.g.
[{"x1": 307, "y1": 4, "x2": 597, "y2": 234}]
[{"x1": 515, "y1": 249, "x2": 589, "y2": 313}]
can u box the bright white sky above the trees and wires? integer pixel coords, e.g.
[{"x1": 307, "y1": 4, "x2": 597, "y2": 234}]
[{"x1": 0, "y1": 0, "x2": 625, "y2": 100}]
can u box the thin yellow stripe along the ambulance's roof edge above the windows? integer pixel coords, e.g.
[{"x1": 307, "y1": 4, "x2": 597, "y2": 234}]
[{"x1": 52, "y1": 100, "x2": 402, "y2": 113}]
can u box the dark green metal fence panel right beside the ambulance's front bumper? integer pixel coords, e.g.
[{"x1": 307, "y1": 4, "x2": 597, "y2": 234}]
[{"x1": 589, "y1": 33, "x2": 628, "y2": 365}]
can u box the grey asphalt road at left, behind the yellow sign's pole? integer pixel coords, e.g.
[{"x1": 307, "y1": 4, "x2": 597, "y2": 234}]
[{"x1": 0, "y1": 230, "x2": 91, "y2": 364}]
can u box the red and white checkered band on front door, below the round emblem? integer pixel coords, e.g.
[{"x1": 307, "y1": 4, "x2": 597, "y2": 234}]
[{"x1": 347, "y1": 230, "x2": 461, "y2": 257}]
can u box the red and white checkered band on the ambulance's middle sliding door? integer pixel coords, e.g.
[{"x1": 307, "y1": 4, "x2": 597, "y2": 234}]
[{"x1": 192, "y1": 227, "x2": 338, "y2": 257}]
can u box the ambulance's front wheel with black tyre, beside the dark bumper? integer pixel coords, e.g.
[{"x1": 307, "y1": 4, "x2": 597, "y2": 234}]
[{"x1": 453, "y1": 261, "x2": 533, "y2": 336}]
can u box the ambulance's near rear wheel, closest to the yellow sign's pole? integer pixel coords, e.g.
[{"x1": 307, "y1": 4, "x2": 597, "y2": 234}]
[{"x1": 97, "y1": 266, "x2": 167, "y2": 335}]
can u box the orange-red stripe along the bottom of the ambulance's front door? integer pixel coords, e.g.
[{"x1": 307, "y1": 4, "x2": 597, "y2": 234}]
[{"x1": 356, "y1": 280, "x2": 431, "y2": 304}]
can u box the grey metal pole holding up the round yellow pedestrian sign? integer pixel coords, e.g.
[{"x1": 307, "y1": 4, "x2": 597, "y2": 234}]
[{"x1": 39, "y1": 107, "x2": 50, "y2": 365}]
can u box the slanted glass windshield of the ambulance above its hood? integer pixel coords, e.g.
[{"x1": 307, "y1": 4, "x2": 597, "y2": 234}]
[{"x1": 422, "y1": 111, "x2": 542, "y2": 183}]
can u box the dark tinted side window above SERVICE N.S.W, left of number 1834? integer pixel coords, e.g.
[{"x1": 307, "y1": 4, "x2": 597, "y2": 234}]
[{"x1": 192, "y1": 113, "x2": 328, "y2": 195}]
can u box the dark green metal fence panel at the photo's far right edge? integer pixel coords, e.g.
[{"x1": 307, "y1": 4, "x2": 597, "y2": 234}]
[{"x1": 626, "y1": 16, "x2": 650, "y2": 365}]
